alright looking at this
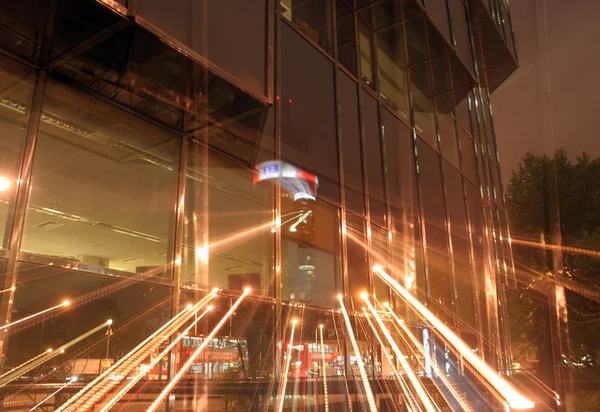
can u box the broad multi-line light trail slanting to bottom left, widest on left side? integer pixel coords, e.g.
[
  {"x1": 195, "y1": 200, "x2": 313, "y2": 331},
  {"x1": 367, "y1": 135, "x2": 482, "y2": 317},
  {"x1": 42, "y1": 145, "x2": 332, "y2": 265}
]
[{"x1": 65, "y1": 288, "x2": 219, "y2": 412}]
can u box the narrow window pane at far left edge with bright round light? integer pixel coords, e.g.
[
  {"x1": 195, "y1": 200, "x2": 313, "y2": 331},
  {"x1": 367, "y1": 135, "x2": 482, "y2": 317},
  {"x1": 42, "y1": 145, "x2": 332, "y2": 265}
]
[{"x1": 0, "y1": 58, "x2": 35, "y2": 247}]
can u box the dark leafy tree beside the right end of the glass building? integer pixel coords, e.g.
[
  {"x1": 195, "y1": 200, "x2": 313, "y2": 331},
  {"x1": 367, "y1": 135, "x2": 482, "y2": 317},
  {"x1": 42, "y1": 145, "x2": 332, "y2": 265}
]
[{"x1": 506, "y1": 149, "x2": 600, "y2": 386}]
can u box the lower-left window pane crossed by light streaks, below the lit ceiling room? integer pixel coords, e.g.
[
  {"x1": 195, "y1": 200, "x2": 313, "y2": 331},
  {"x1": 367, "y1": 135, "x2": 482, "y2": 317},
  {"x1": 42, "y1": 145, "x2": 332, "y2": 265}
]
[{"x1": 7, "y1": 262, "x2": 171, "y2": 370}]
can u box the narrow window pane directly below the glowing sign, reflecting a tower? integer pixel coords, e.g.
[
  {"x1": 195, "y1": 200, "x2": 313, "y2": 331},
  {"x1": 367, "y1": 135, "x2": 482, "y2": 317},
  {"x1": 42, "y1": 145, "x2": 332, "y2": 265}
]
[{"x1": 281, "y1": 196, "x2": 342, "y2": 306}]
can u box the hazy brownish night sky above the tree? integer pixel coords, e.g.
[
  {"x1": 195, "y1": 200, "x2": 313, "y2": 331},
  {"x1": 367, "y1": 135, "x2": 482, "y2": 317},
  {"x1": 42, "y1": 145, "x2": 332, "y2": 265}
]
[{"x1": 492, "y1": 0, "x2": 600, "y2": 186}]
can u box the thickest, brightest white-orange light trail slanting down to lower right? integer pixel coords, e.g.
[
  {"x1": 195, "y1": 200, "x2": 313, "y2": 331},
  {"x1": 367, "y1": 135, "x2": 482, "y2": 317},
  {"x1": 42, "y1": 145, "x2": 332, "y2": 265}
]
[{"x1": 373, "y1": 265, "x2": 535, "y2": 409}]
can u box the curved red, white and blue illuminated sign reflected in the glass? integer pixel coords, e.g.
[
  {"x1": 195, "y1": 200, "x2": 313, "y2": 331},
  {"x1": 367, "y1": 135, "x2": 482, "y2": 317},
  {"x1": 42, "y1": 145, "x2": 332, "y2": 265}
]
[{"x1": 254, "y1": 160, "x2": 319, "y2": 200}]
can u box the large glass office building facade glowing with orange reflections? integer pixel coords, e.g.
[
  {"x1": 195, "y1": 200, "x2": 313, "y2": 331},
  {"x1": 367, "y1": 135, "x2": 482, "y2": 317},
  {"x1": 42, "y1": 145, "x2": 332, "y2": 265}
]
[{"x1": 0, "y1": 0, "x2": 517, "y2": 410}]
